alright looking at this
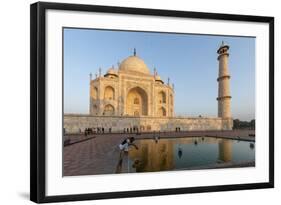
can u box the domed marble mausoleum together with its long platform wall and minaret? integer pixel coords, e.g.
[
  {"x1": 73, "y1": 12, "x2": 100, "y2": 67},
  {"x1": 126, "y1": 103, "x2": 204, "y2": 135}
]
[{"x1": 64, "y1": 42, "x2": 233, "y2": 133}]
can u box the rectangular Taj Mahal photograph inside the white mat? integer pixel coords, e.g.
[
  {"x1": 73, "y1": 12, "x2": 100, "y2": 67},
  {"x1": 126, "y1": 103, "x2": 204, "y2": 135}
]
[{"x1": 61, "y1": 27, "x2": 256, "y2": 177}]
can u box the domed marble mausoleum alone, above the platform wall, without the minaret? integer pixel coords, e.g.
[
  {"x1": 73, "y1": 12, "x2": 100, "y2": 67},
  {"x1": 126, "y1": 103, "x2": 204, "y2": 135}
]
[{"x1": 90, "y1": 47, "x2": 174, "y2": 117}]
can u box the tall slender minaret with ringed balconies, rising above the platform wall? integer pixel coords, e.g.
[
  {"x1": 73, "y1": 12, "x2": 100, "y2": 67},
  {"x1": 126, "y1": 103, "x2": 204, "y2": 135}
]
[{"x1": 217, "y1": 42, "x2": 231, "y2": 118}]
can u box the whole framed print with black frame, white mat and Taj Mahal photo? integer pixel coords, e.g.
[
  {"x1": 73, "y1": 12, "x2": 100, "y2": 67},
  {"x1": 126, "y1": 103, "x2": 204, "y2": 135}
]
[{"x1": 30, "y1": 2, "x2": 274, "y2": 203}]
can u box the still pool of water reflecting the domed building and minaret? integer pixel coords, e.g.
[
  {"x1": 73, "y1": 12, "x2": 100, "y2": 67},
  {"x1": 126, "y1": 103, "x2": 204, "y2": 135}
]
[{"x1": 128, "y1": 137, "x2": 255, "y2": 172}]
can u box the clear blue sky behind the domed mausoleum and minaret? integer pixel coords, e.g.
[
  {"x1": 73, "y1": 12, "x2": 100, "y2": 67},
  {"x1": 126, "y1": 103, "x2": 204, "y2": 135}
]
[{"x1": 64, "y1": 28, "x2": 255, "y2": 120}]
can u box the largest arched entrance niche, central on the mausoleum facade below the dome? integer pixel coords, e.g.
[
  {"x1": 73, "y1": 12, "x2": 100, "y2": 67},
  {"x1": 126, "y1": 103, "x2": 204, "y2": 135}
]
[{"x1": 126, "y1": 87, "x2": 148, "y2": 116}]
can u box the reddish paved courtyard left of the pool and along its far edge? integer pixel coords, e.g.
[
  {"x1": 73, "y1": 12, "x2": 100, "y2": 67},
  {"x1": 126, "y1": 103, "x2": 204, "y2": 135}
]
[{"x1": 63, "y1": 131, "x2": 255, "y2": 176}]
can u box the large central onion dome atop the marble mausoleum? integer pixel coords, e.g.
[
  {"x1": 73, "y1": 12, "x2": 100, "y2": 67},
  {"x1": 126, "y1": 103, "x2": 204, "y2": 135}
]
[{"x1": 119, "y1": 55, "x2": 150, "y2": 74}]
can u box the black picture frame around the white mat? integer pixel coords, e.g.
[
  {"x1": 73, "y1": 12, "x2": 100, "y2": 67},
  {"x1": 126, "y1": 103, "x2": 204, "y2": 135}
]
[{"x1": 30, "y1": 2, "x2": 274, "y2": 203}]
